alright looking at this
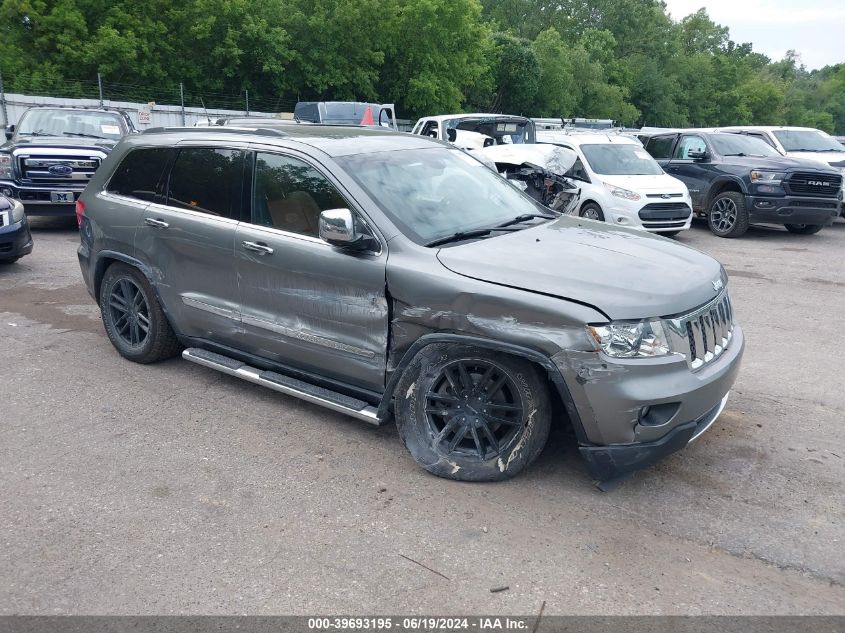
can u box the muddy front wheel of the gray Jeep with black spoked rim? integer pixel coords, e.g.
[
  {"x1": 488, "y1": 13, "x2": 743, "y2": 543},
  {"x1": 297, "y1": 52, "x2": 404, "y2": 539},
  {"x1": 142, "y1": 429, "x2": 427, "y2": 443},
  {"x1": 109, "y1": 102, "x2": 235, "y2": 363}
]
[{"x1": 395, "y1": 344, "x2": 551, "y2": 481}]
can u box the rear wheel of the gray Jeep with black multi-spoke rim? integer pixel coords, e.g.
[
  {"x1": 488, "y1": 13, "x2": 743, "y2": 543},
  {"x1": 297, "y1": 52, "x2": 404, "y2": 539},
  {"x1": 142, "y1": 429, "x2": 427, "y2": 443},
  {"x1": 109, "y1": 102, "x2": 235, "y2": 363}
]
[{"x1": 100, "y1": 264, "x2": 180, "y2": 364}]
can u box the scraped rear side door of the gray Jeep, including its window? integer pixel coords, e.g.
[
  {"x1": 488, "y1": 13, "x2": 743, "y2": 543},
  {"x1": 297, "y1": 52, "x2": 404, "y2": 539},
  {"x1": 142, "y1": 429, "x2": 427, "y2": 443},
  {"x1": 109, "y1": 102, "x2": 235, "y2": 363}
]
[{"x1": 135, "y1": 145, "x2": 247, "y2": 347}]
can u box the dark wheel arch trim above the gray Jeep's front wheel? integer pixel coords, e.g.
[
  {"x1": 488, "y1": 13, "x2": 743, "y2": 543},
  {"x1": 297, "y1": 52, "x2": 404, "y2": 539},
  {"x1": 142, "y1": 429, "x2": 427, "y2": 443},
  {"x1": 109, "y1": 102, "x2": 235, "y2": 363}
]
[{"x1": 378, "y1": 333, "x2": 588, "y2": 443}]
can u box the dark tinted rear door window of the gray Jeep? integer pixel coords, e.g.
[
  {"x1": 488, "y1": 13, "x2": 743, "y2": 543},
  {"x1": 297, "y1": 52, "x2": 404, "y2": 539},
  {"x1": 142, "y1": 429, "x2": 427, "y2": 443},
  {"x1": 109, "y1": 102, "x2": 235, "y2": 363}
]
[{"x1": 167, "y1": 147, "x2": 244, "y2": 219}]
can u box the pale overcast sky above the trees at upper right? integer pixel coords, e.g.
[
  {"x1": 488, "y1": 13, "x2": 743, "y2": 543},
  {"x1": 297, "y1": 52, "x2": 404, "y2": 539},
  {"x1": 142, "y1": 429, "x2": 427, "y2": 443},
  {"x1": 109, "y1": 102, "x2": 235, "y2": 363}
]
[{"x1": 664, "y1": 0, "x2": 845, "y2": 70}]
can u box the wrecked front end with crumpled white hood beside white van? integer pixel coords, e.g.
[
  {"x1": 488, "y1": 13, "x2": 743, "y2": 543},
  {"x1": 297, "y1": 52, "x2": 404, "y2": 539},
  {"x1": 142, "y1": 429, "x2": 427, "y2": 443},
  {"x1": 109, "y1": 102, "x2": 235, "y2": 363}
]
[{"x1": 470, "y1": 145, "x2": 581, "y2": 213}]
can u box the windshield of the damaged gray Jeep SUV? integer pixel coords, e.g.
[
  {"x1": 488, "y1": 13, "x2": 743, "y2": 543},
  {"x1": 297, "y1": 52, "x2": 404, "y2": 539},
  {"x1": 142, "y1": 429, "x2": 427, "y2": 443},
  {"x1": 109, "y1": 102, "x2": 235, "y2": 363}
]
[{"x1": 338, "y1": 147, "x2": 549, "y2": 244}]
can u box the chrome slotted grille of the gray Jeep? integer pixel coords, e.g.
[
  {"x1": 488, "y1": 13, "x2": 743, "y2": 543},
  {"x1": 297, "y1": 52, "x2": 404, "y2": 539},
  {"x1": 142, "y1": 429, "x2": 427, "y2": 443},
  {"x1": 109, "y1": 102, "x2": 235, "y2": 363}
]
[{"x1": 666, "y1": 290, "x2": 734, "y2": 370}]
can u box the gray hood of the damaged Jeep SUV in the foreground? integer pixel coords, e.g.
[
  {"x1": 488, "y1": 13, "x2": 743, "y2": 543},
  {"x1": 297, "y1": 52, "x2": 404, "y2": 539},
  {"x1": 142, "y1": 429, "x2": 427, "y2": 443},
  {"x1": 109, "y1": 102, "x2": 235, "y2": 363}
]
[{"x1": 437, "y1": 216, "x2": 724, "y2": 319}]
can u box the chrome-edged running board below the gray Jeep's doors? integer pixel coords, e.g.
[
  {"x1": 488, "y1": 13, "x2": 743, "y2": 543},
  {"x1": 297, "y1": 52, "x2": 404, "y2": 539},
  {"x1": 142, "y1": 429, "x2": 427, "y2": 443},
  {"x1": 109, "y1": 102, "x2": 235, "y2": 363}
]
[{"x1": 182, "y1": 347, "x2": 383, "y2": 426}]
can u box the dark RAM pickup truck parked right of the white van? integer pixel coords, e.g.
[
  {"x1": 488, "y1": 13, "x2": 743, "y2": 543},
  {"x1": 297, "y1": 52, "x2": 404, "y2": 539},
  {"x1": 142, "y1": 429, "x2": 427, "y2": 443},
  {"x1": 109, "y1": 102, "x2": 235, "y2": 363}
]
[{"x1": 641, "y1": 130, "x2": 842, "y2": 237}]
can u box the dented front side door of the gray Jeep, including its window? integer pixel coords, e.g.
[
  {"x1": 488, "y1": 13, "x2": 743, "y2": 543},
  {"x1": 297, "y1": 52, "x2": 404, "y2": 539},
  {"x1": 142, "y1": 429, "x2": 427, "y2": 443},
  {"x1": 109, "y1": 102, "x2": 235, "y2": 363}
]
[{"x1": 235, "y1": 151, "x2": 388, "y2": 391}]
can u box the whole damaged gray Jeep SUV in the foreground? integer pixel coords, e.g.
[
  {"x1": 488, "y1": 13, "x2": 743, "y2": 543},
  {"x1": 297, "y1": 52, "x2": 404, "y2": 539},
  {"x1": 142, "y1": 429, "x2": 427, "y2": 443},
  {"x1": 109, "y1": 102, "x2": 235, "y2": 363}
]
[{"x1": 77, "y1": 125, "x2": 744, "y2": 481}]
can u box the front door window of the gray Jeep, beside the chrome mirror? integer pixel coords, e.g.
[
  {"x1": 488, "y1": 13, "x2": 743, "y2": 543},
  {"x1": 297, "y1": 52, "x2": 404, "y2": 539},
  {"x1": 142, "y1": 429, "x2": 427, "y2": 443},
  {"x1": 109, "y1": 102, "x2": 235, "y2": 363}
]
[{"x1": 252, "y1": 153, "x2": 349, "y2": 237}]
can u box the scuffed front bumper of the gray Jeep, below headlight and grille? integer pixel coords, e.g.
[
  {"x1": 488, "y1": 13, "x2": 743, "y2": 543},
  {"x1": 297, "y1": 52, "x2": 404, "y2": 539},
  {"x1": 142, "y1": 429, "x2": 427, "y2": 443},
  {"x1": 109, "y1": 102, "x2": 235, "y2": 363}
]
[{"x1": 553, "y1": 324, "x2": 745, "y2": 480}]
